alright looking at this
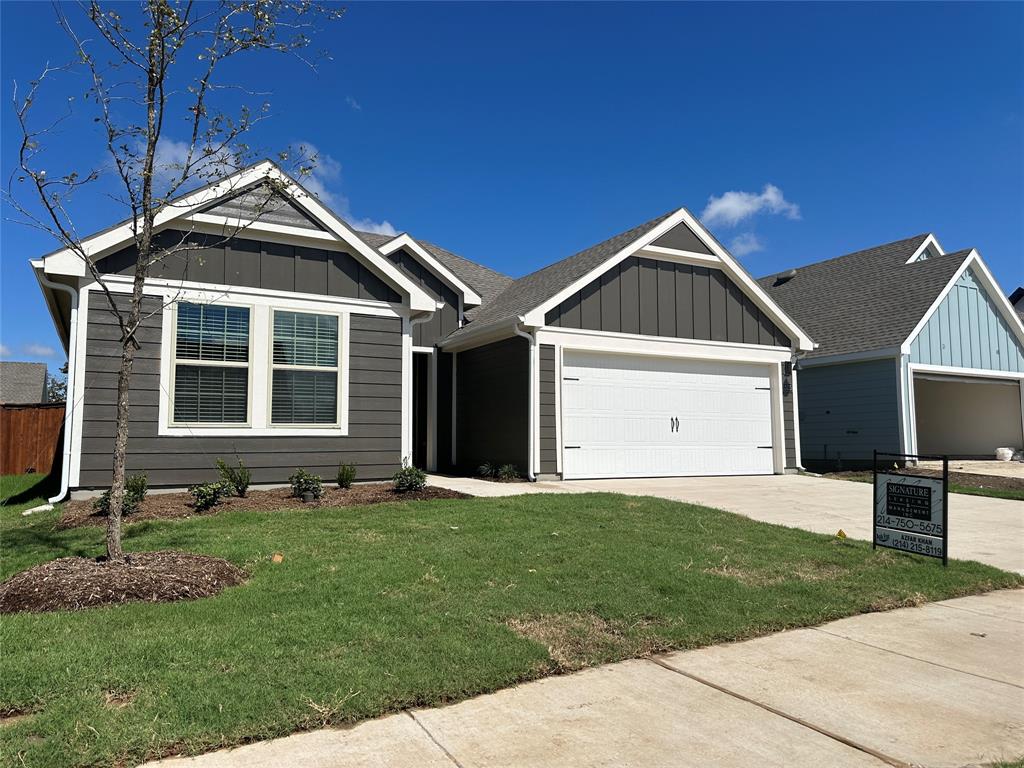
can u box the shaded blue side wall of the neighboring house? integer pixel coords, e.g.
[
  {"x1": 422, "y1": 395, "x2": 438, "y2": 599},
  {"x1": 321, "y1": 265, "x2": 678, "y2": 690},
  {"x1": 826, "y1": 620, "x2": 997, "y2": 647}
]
[{"x1": 799, "y1": 358, "x2": 900, "y2": 469}]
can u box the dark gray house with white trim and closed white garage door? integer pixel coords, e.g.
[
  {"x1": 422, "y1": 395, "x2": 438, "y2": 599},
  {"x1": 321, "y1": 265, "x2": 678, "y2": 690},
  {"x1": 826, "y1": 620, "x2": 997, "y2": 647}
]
[{"x1": 32, "y1": 162, "x2": 813, "y2": 499}]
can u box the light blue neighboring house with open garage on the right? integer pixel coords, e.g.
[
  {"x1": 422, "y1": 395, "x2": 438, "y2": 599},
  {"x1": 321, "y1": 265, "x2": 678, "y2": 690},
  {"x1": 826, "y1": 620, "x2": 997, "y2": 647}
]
[{"x1": 760, "y1": 234, "x2": 1024, "y2": 469}]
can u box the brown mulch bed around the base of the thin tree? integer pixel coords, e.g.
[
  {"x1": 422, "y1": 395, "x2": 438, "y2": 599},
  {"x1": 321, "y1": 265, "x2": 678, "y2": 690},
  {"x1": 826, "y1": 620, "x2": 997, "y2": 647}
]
[{"x1": 0, "y1": 551, "x2": 246, "y2": 613}]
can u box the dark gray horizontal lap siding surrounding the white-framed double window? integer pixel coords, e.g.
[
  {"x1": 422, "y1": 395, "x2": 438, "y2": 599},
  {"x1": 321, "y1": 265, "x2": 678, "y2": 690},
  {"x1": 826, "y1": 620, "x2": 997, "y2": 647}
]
[{"x1": 79, "y1": 292, "x2": 402, "y2": 488}]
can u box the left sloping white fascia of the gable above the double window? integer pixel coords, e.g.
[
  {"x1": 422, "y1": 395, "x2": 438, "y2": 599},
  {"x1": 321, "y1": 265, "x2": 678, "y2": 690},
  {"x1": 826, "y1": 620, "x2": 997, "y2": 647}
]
[{"x1": 43, "y1": 160, "x2": 274, "y2": 276}]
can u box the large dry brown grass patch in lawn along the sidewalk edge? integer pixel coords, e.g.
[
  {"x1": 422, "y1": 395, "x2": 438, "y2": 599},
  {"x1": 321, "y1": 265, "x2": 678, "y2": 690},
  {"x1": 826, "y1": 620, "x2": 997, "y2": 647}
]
[{"x1": 506, "y1": 613, "x2": 667, "y2": 672}]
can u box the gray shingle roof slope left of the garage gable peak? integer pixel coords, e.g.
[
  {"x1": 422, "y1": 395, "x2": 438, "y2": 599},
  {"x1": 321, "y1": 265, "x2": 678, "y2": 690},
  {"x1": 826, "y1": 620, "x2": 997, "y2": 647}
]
[{"x1": 449, "y1": 211, "x2": 675, "y2": 339}]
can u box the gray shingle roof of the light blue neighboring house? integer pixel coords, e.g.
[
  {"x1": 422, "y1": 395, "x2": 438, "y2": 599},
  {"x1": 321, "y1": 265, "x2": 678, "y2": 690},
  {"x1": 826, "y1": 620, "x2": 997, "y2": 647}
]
[{"x1": 759, "y1": 233, "x2": 972, "y2": 357}]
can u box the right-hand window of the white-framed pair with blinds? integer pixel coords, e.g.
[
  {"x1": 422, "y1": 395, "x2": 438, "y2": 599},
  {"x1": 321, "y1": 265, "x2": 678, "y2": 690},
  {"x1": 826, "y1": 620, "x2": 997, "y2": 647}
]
[{"x1": 270, "y1": 310, "x2": 338, "y2": 426}]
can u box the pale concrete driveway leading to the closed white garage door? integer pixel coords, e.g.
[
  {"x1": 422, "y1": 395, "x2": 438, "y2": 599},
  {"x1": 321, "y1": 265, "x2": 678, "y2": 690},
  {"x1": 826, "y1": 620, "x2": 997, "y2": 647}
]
[{"x1": 561, "y1": 475, "x2": 1024, "y2": 573}]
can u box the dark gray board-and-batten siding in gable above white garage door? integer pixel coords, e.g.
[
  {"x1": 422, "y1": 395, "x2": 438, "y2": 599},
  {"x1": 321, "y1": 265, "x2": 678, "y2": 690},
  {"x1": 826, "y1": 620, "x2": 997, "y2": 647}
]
[{"x1": 545, "y1": 256, "x2": 790, "y2": 346}]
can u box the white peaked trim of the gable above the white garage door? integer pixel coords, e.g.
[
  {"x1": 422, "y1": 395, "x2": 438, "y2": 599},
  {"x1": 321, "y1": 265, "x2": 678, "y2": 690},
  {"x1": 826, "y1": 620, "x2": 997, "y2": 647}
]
[{"x1": 525, "y1": 208, "x2": 814, "y2": 350}]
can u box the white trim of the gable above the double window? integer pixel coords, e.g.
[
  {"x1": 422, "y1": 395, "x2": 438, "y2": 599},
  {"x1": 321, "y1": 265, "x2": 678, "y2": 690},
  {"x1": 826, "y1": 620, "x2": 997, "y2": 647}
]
[{"x1": 35, "y1": 160, "x2": 436, "y2": 312}]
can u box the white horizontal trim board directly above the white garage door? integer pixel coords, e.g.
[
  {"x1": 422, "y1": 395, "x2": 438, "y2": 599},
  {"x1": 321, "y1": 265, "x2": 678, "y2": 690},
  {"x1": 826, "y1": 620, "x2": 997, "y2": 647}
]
[{"x1": 537, "y1": 328, "x2": 793, "y2": 365}]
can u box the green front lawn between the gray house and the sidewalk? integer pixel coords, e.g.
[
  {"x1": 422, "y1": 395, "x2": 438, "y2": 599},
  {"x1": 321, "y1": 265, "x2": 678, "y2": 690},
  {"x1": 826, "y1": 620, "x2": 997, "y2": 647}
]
[{"x1": 0, "y1": 478, "x2": 1022, "y2": 765}]
